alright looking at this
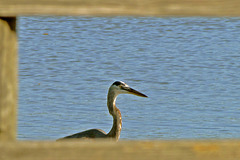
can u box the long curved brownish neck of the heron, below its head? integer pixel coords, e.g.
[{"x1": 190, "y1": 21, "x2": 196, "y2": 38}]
[{"x1": 107, "y1": 90, "x2": 122, "y2": 141}]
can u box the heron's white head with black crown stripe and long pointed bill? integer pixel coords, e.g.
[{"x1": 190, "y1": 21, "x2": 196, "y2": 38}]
[{"x1": 111, "y1": 81, "x2": 147, "y2": 97}]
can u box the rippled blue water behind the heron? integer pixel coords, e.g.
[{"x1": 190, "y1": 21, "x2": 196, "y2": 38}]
[{"x1": 18, "y1": 17, "x2": 240, "y2": 140}]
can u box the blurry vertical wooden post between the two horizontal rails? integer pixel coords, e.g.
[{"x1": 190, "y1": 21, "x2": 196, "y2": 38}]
[{"x1": 0, "y1": 17, "x2": 18, "y2": 141}]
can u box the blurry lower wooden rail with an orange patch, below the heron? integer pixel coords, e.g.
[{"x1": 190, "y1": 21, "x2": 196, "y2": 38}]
[{"x1": 0, "y1": 140, "x2": 240, "y2": 160}]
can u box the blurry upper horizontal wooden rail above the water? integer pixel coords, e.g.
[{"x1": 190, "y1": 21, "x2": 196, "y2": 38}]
[{"x1": 0, "y1": 0, "x2": 240, "y2": 16}]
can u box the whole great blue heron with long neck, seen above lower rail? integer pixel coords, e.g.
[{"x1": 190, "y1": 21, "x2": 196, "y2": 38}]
[{"x1": 58, "y1": 81, "x2": 147, "y2": 141}]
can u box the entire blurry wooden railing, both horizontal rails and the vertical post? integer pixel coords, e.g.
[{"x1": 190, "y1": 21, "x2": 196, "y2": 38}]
[{"x1": 0, "y1": 0, "x2": 240, "y2": 160}]
